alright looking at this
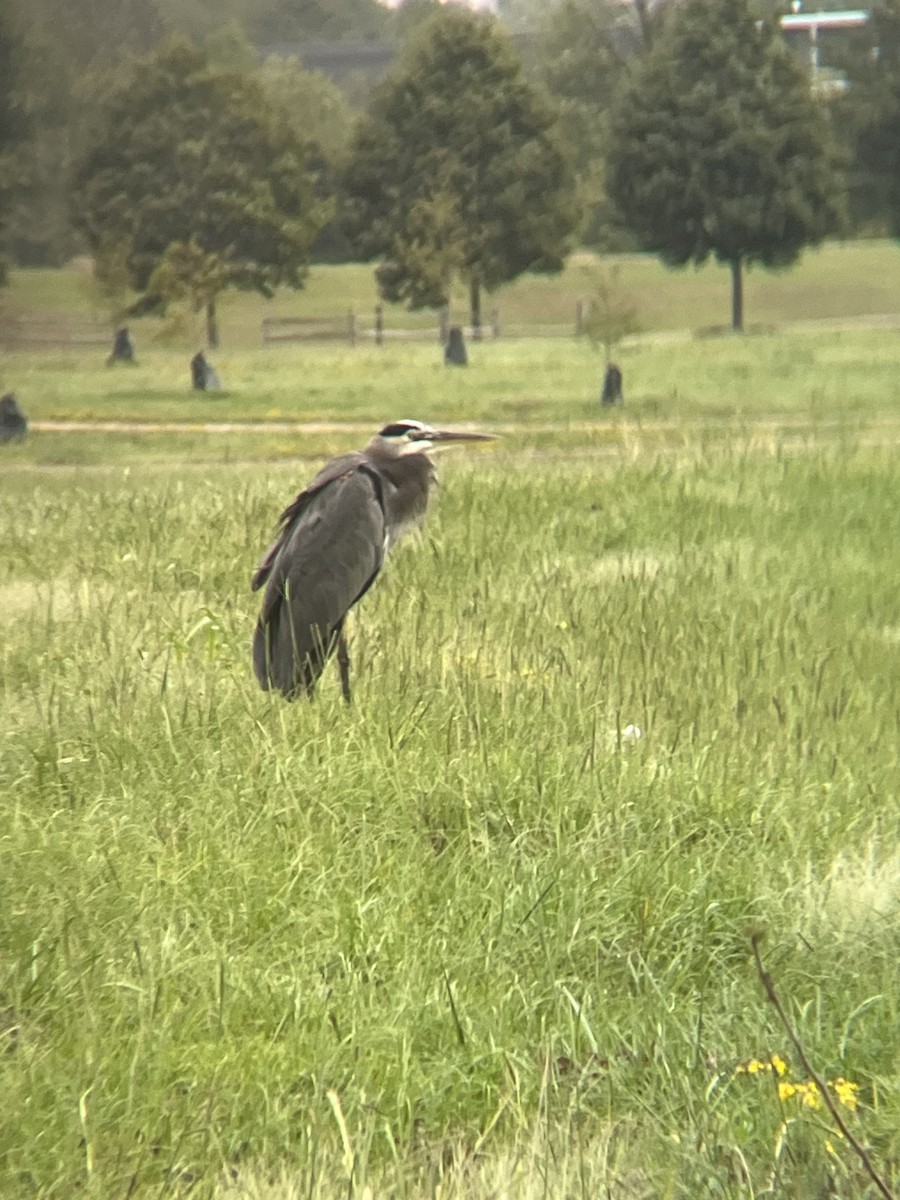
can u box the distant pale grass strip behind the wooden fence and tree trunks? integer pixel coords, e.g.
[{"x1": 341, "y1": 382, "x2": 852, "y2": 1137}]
[{"x1": 0, "y1": 240, "x2": 900, "y2": 350}]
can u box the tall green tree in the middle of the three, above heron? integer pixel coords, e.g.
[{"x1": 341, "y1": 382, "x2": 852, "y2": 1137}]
[{"x1": 343, "y1": 7, "x2": 576, "y2": 326}]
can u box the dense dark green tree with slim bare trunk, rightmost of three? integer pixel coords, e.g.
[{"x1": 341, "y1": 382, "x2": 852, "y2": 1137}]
[{"x1": 607, "y1": 0, "x2": 845, "y2": 329}]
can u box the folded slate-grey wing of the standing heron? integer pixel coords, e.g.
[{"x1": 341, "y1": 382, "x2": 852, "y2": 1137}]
[{"x1": 253, "y1": 461, "x2": 385, "y2": 694}]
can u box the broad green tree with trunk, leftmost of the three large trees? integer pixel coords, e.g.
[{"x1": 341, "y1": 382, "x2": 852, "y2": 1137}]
[{"x1": 73, "y1": 41, "x2": 328, "y2": 342}]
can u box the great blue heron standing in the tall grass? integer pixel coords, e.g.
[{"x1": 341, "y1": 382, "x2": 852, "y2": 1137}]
[{"x1": 251, "y1": 420, "x2": 493, "y2": 703}]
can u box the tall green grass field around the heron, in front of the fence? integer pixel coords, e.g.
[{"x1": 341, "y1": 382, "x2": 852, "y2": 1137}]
[{"x1": 0, "y1": 260, "x2": 900, "y2": 1200}]
